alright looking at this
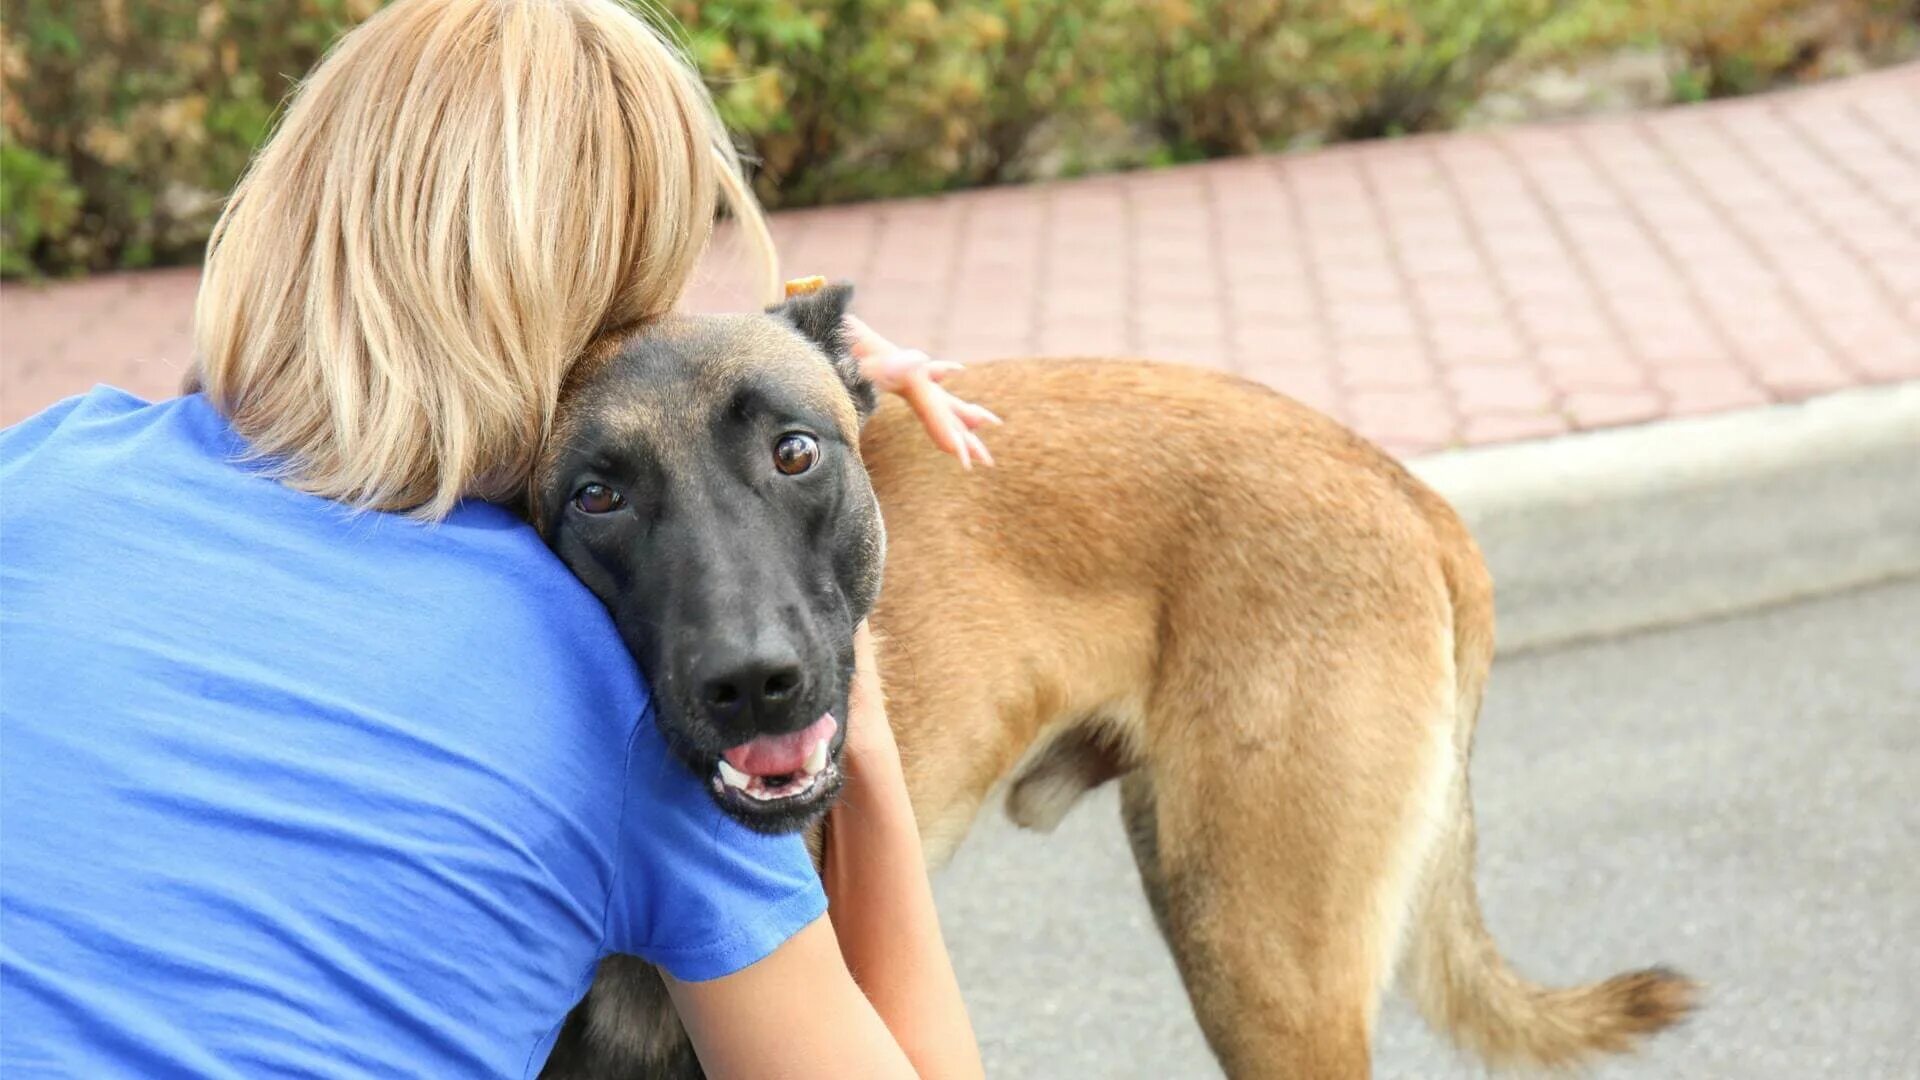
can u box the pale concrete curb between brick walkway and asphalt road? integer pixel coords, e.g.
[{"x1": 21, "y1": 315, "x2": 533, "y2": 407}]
[{"x1": 1411, "y1": 382, "x2": 1920, "y2": 655}]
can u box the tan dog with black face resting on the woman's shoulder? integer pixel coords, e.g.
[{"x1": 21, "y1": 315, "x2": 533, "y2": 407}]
[{"x1": 528, "y1": 286, "x2": 1697, "y2": 1078}]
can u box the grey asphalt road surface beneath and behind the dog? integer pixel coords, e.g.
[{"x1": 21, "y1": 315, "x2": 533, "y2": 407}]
[{"x1": 937, "y1": 582, "x2": 1920, "y2": 1080}]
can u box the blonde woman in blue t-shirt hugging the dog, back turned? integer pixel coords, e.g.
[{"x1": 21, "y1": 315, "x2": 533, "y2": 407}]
[{"x1": 0, "y1": 0, "x2": 987, "y2": 1076}]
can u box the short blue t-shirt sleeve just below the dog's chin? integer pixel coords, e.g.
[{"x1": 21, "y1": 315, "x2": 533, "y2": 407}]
[{"x1": 607, "y1": 709, "x2": 828, "y2": 982}]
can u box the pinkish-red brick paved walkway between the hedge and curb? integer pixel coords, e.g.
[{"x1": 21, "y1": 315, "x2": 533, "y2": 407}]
[{"x1": 0, "y1": 65, "x2": 1920, "y2": 454}]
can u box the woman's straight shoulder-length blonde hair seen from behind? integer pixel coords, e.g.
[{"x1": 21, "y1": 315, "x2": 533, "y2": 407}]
[{"x1": 190, "y1": 0, "x2": 780, "y2": 517}]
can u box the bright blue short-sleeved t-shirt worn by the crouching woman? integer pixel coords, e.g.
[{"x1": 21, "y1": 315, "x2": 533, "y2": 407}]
[{"x1": 0, "y1": 388, "x2": 826, "y2": 1078}]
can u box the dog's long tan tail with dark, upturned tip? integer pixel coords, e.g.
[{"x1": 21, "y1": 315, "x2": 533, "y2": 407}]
[{"x1": 1402, "y1": 498, "x2": 1699, "y2": 1068}]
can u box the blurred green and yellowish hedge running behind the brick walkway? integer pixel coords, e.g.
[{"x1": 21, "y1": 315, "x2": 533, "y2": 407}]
[{"x1": 0, "y1": 0, "x2": 1916, "y2": 275}]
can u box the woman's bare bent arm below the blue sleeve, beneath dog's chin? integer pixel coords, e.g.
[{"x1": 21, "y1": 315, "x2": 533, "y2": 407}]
[{"x1": 666, "y1": 626, "x2": 983, "y2": 1080}]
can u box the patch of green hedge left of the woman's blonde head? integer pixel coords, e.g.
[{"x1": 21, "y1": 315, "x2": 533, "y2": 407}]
[{"x1": 0, "y1": 0, "x2": 378, "y2": 275}]
